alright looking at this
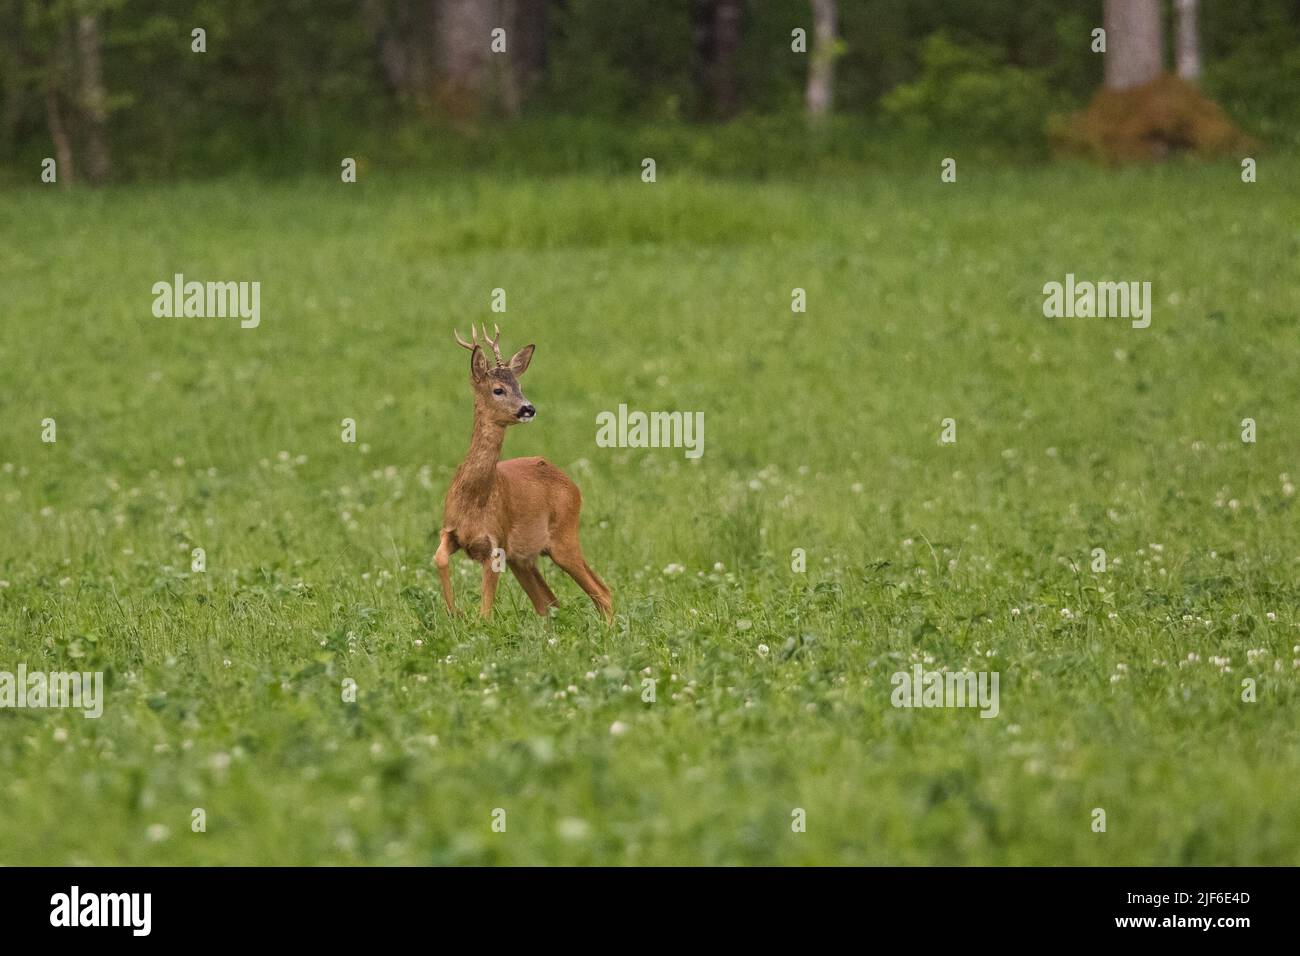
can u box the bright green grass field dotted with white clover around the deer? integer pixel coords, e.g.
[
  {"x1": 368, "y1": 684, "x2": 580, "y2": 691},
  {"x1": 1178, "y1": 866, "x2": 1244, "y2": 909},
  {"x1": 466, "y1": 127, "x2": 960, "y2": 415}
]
[{"x1": 0, "y1": 157, "x2": 1300, "y2": 865}]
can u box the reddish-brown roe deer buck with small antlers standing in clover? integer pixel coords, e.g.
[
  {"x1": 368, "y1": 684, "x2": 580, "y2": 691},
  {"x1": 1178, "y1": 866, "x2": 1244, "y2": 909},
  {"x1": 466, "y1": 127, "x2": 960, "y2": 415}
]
[{"x1": 433, "y1": 325, "x2": 614, "y2": 620}]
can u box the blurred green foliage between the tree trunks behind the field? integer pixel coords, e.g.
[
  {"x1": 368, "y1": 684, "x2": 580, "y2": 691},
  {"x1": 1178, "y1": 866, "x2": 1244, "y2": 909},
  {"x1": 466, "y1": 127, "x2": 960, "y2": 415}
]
[{"x1": 0, "y1": 0, "x2": 1300, "y2": 182}]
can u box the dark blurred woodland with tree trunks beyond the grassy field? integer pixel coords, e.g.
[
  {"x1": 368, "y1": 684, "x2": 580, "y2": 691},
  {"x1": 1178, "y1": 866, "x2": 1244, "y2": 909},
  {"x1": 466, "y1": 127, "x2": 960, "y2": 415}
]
[{"x1": 0, "y1": 0, "x2": 1300, "y2": 185}]
